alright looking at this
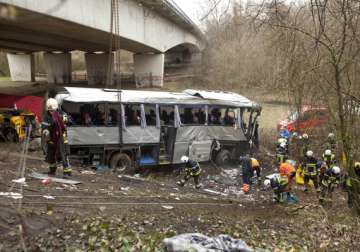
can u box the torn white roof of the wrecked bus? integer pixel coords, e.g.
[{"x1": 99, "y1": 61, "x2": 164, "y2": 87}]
[{"x1": 57, "y1": 87, "x2": 260, "y2": 108}]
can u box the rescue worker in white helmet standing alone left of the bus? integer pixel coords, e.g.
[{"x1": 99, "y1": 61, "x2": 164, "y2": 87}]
[{"x1": 42, "y1": 98, "x2": 72, "y2": 177}]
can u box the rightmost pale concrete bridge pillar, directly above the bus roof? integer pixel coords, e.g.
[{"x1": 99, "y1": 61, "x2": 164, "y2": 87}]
[{"x1": 134, "y1": 53, "x2": 165, "y2": 87}]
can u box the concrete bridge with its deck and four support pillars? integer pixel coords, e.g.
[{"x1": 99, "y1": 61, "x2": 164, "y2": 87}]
[{"x1": 0, "y1": 0, "x2": 205, "y2": 86}]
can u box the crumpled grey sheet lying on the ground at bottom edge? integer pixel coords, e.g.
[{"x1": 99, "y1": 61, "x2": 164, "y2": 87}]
[{"x1": 163, "y1": 233, "x2": 253, "y2": 252}]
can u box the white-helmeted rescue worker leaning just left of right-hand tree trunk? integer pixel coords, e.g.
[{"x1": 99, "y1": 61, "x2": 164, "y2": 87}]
[{"x1": 319, "y1": 166, "x2": 340, "y2": 203}]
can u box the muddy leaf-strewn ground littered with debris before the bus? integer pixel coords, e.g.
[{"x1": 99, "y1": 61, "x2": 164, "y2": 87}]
[{"x1": 0, "y1": 143, "x2": 360, "y2": 251}]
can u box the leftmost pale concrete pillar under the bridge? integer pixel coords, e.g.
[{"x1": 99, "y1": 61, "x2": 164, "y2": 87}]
[{"x1": 7, "y1": 53, "x2": 35, "y2": 81}]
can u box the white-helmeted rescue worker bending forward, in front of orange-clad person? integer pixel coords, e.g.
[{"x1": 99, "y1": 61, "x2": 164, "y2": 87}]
[{"x1": 264, "y1": 174, "x2": 289, "y2": 203}]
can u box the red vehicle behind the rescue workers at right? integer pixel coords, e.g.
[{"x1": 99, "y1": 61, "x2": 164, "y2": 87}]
[{"x1": 277, "y1": 106, "x2": 329, "y2": 133}]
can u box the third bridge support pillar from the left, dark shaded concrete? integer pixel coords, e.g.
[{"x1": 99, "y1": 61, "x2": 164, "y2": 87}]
[{"x1": 85, "y1": 53, "x2": 114, "y2": 86}]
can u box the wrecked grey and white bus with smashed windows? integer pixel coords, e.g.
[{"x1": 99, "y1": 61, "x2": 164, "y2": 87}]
[{"x1": 56, "y1": 87, "x2": 261, "y2": 172}]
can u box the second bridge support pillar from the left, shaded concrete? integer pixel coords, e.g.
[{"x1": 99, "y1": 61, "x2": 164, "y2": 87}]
[{"x1": 44, "y1": 53, "x2": 71, "y2": 84}]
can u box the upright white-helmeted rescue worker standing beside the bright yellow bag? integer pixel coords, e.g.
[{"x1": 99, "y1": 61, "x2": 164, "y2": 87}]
[{"x1": 301, "y1": 150, "x2": 319, "y2": 192}]
